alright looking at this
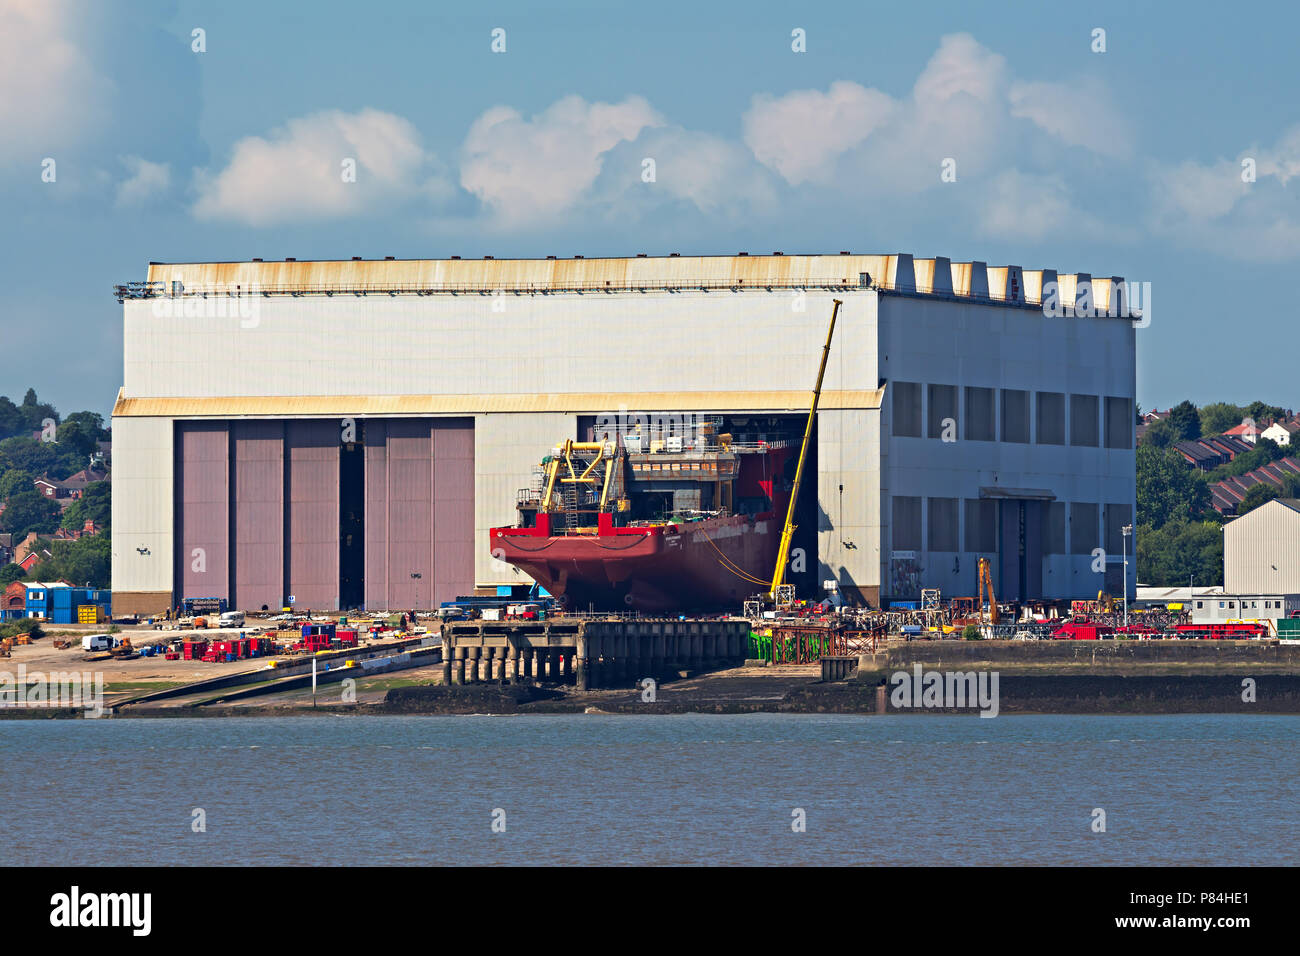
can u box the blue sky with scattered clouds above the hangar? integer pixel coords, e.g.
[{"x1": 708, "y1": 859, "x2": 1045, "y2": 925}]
[{"x1": 0, "y1": 0, "x2": 1300, "y2": 416}]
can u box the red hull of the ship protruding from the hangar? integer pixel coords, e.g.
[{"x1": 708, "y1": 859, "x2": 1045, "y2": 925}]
[{"x1": 491, "y1": 512, "x2": 781, "y2": 611}]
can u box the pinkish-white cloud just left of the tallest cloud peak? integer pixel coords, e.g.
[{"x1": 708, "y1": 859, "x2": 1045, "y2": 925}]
[{"x1": 744, "y1": 79, "x2": 897, "y2": 186}]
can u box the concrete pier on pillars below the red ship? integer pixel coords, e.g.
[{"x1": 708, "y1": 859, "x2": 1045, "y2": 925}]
[{"x1": 442, "y1": 618, "x2": 750, "y2": 691}]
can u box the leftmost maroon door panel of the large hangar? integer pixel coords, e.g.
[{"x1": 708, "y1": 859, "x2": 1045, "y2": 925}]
[{"x1": 174, "y1": 421, "x2": 230, "y2": 598}]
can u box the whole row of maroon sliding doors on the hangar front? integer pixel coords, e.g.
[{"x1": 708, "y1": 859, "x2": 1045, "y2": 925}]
[{"x1": 174, "y1": 419, "x2": 475, "y2": 610}]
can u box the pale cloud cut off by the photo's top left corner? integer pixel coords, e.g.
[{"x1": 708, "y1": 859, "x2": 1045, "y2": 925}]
[{"x1": 0, "y1": 0, "x2": 113, "y2": 164}]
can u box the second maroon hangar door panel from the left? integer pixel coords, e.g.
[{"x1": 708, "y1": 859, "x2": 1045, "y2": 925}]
[{"x1": 230, "y1": 421, "x2": 285, "y2": 610}]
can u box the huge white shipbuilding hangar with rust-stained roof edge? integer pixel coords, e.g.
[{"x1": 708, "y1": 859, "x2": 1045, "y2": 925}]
[{"x1": 113, "y1": 252, "x2": 1138, "y2": 614}]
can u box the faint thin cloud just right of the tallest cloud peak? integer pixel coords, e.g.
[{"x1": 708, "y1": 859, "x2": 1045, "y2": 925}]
[{"x1": 1009, "y1": 77, "x2": 1132, "y2": 156}]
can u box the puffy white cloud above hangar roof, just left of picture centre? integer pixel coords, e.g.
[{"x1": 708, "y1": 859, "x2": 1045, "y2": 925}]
[{"x1": 460, "y1": 96, "x2": 663, "y2": 225}]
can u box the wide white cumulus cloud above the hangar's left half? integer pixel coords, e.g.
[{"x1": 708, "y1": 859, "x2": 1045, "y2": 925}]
[{"x1": 194, "y1": 109, "x2": 451, "y2": 226}]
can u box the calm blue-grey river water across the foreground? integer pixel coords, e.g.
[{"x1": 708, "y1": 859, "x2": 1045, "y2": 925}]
[{"x1": 0, "y1": 714, "x2": 1300, "y2": 865}]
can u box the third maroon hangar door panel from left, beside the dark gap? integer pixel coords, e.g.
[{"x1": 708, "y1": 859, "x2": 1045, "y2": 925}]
[{"x1": 285, "y1": 420, "x2": 341, "y2": 610}]
